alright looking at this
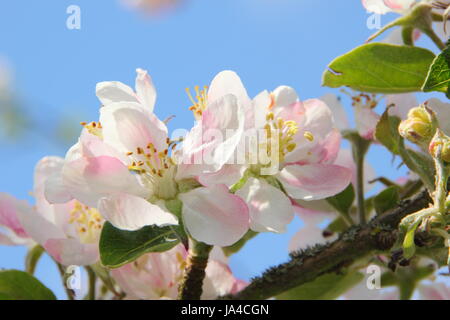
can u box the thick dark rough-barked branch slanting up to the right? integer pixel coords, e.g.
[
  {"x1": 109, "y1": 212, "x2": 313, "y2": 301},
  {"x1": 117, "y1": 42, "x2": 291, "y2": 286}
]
[{"x1": 221, "y1": 191, "x2": 431, "y2": 300}]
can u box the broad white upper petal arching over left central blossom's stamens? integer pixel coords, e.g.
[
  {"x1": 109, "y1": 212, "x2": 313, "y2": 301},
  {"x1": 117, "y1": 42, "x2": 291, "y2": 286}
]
[{"x1": 100, "y1": 102, "x2": 167, "y2": 153}]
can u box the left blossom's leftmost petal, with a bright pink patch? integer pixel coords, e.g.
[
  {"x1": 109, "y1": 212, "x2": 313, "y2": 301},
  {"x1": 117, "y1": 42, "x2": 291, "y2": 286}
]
[{"x1": 62, "y1": 156, "x2": 147, "y2": 208}]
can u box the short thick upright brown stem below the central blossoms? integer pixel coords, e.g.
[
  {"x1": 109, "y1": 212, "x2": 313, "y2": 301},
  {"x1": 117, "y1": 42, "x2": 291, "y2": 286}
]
[{"x1": 178, "y1": 240, "x2": 213, "y2": 300}]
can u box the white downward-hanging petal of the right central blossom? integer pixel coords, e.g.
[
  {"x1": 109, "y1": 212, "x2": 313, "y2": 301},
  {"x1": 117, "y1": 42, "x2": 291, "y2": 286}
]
[{"x1": 236, "y1": 178, "x2": 294, "y2": 233}]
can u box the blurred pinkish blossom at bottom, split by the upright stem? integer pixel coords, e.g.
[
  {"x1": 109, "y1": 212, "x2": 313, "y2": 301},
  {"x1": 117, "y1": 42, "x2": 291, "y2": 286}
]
[{"x1": 111, "y1": 245, "x2": 246, "y2": 300}]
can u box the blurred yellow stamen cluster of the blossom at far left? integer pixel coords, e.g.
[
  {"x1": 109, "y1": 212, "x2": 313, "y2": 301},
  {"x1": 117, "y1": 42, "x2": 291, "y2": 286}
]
[{"x1": 69, "y1": 201, "x2": 104, "y2": 243}]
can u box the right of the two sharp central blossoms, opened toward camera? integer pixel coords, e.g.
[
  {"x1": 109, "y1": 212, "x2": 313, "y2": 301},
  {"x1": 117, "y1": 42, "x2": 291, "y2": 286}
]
[{"x1": 178, "y1": 71, "x2": 350, "y2": 232}]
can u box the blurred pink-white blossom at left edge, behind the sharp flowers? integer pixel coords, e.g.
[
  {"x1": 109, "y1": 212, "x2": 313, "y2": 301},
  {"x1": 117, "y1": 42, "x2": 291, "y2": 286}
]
[{"x1": 0, "y1": 157, "x2": 103, "y2": 266}]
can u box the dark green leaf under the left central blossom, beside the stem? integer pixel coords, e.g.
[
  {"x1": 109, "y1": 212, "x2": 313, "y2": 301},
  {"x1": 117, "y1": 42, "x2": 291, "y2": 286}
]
[{"x1": 99, "y1": 222, "x2": 179, "y2": 268}]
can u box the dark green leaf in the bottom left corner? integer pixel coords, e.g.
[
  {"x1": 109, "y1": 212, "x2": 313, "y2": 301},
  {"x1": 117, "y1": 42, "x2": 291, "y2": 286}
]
[{"x1": 0, "y1": 270, "x2": 56, "y2": 300}]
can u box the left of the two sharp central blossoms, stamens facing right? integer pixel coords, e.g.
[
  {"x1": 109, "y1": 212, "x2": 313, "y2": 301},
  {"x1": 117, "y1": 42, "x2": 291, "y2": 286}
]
[{"x1": 47, "y1": 69, "x2": 248, "y2": 246}]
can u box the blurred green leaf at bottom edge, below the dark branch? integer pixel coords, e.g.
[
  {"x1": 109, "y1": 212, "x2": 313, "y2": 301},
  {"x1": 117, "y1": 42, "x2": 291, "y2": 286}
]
[{"x1": 277, "y1": 271, "x2": 364, "y2": 300}]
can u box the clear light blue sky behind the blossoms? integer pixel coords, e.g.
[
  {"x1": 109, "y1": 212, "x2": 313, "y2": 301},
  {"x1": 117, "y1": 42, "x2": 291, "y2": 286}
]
[{"x1": 0, "y1": 0, "x2": 442, "y2": 297}]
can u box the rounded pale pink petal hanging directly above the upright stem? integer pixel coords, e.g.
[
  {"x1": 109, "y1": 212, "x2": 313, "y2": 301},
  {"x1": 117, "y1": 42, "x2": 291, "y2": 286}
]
[{"x1": 179, "y1": 185, "x2": 249, "y2": 246}]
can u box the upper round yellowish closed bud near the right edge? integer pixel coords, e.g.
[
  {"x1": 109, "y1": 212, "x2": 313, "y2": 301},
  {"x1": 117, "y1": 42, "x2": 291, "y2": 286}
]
[{"x1": 398, "y1": 106, "x2": 438, "y2": 146}]
